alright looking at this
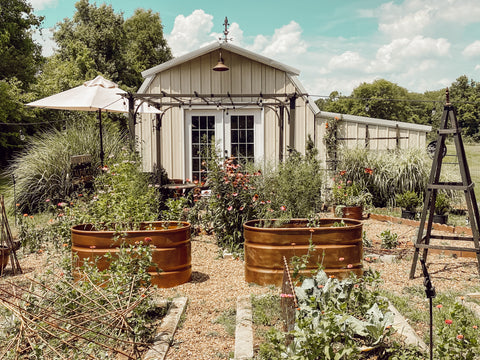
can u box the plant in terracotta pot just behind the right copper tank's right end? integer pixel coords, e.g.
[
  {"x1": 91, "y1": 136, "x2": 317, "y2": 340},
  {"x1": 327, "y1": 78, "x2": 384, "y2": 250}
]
[{"x1": 332, "y1": 172, "x2": 372, "y2": 220}]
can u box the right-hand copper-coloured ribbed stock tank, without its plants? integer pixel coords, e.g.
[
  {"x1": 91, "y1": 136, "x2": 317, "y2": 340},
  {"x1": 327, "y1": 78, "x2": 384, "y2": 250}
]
[{"x1": 243, "y1": 218, "x2": 363, "y2": 286}]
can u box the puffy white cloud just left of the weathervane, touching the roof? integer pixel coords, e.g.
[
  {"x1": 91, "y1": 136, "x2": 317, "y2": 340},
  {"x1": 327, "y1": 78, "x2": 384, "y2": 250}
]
[{"x1": 166, "y1": 10, "x2": 215, "y2": 56}]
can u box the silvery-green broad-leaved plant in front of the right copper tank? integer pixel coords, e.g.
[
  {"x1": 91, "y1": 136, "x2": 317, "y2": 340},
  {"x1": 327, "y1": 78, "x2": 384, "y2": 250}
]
[{"x1": 261, "y1": 270, "x2": 393, "y2": 360}]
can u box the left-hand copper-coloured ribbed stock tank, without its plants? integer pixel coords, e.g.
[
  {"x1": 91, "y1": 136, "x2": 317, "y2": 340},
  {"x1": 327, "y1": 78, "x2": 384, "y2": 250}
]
[{"x1": 71, "y1": 221, "x2": 192, "y2": 288}]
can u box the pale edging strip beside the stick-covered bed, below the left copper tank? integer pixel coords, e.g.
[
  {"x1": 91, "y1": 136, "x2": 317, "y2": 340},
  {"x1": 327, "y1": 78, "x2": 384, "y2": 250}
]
[{"x1": 142, "y1": 297, "x2": 188, "y2": 360}]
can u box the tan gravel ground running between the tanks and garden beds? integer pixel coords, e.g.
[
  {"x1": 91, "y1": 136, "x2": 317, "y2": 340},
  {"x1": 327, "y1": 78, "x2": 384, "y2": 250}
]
[{"x1": 0, "y1": 215, "x2": 480, "y2": 360}]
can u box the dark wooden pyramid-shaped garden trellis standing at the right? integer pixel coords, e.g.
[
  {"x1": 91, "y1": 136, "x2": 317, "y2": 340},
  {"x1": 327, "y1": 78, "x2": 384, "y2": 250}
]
[{"x1": 410, "y1": 89, "x2": 480, "y2": 279}]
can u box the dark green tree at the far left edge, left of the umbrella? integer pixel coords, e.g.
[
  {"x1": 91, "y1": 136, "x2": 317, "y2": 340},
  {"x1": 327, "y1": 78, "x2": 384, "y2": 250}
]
[{"x1": 0, "y1": 0, "x2": 43, "y2": 166}]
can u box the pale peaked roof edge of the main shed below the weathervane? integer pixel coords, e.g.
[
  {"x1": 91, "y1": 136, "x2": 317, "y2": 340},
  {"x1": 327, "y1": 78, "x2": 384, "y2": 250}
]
[{"x1": 142, "y1": 43, "x2": 300, "y2": 78}]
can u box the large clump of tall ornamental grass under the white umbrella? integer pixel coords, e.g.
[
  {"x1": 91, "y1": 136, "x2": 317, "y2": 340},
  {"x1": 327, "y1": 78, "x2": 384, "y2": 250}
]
[{"x1": 7, "y1": 119, "x2": 123, "y2": 213}]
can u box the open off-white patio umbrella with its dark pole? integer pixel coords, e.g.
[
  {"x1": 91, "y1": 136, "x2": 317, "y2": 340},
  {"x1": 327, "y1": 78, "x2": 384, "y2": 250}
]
[{"x1": 27, "y1": 75, "x2": 160, "y2": 165}]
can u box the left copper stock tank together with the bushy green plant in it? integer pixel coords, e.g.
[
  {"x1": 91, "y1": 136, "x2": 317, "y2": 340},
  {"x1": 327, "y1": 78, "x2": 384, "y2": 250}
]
[{"x1": 69, "y1": 153, "x2": 192, "y2": 287}]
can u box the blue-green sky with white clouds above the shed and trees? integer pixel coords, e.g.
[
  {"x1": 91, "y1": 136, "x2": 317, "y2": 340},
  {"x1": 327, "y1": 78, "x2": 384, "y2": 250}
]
[{"x1": 29, "y1": 0, "x2": 480, "y2": 96}]
